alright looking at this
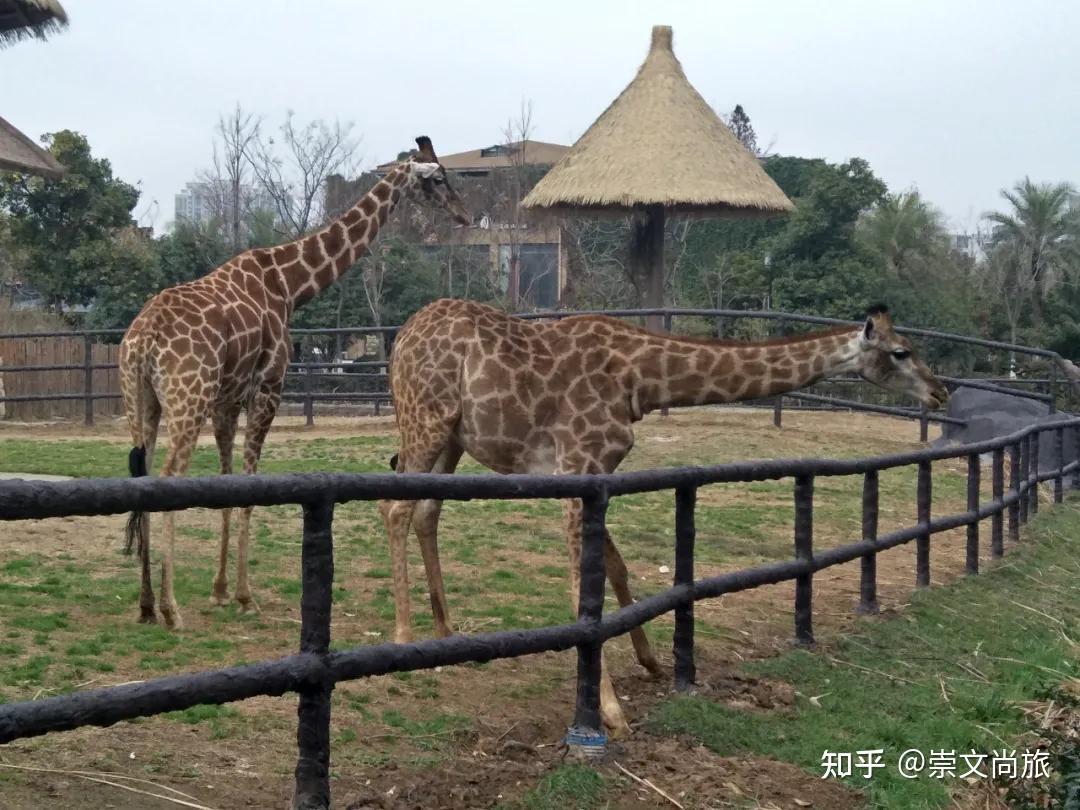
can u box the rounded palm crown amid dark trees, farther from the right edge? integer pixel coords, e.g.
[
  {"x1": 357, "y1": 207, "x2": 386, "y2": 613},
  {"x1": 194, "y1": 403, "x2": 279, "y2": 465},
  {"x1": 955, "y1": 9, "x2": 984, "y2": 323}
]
[{"x1": 859, "y1": 191, "x2": 948, "y2": 282}]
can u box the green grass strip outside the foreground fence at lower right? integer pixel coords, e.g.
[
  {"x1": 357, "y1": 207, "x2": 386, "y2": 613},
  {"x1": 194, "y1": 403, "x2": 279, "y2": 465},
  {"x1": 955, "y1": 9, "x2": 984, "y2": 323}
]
[{"x1": 649, "y1": 501, "x2": 1080, "y2": 810}]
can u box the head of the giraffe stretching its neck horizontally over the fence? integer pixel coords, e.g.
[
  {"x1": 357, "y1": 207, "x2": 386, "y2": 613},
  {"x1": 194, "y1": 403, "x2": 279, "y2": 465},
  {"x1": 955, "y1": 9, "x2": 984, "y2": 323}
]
[{"x1": 855, "y1": 305, "x2": 948, "y2": 408}]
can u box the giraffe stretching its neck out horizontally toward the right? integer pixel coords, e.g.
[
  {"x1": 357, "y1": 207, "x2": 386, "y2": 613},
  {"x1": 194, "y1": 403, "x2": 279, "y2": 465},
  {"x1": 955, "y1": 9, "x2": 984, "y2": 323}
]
[{"x1": 379, "y1": 299, "x2": 948, "y2": 735}]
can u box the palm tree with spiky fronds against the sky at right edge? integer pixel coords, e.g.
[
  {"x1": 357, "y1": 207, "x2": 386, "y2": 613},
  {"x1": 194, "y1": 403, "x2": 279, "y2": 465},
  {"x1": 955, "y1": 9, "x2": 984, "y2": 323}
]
[{"x1": 985, "y1": 177, "x2": 1080, "y2": 316}]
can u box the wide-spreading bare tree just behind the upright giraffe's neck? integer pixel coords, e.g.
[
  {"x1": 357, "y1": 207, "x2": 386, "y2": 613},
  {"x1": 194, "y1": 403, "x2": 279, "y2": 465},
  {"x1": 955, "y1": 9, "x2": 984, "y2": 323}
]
[{"x1": 248, "y1": 111, "x2": 359, "y2": 239}]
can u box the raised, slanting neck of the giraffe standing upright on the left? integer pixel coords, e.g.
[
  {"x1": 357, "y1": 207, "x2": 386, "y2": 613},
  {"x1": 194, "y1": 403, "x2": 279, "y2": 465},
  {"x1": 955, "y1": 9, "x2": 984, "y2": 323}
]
[{"x1": 274, "y1": 164, "x2": 408, "y2": 311}]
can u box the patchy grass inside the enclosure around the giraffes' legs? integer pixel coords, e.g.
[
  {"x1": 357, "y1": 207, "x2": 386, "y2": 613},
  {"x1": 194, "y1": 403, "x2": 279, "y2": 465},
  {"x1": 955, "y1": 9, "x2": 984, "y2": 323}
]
[{"x1": 0, "y1": 414, "x2": 995, "y2": 808}]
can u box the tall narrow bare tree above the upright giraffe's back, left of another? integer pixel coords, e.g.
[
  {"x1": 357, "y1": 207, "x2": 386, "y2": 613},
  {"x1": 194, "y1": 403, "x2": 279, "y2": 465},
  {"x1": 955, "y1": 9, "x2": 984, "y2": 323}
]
[{"x1": 202, "y1": 103, "x2": 261, "y2": 254}]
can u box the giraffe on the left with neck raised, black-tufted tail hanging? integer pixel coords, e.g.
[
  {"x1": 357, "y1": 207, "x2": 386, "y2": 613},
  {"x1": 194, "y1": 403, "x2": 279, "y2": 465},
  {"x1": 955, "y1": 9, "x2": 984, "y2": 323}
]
[{"x1": 120, "y1": 136, "x2": 472, "y2": 630}]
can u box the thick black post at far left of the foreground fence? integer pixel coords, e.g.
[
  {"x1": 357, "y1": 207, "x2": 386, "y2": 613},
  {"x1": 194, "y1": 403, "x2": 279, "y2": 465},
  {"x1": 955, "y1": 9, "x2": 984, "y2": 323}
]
[{"x1": 293, "y1": 500, "x2": 334, "y2": 810}]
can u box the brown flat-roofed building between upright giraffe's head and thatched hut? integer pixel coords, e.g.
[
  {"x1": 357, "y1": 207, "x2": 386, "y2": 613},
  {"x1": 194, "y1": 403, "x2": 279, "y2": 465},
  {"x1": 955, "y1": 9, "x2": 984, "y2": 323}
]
[{"x1": 362, "y1": 140, "x2": 569, "y2": 309}]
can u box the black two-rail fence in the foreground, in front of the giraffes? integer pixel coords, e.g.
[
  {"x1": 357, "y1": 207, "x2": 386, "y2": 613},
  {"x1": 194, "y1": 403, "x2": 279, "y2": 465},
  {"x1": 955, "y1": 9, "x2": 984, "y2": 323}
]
[{"x1": 0, "y1": 419, "x2": 1080, "y2": 810}]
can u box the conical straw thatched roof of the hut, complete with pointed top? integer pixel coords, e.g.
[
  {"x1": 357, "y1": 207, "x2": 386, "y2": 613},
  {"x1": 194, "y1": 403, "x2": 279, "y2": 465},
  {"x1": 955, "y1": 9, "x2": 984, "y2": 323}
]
[{"x1": 523, "y1": 26, "x2": 794, "y2": 215}]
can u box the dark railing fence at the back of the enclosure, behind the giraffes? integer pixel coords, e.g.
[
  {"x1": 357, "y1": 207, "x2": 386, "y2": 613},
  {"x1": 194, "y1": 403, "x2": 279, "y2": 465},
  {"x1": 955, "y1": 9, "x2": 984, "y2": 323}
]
[{"x1": 0, "y1": 309, "x2": 1069, "y2": 427}]
